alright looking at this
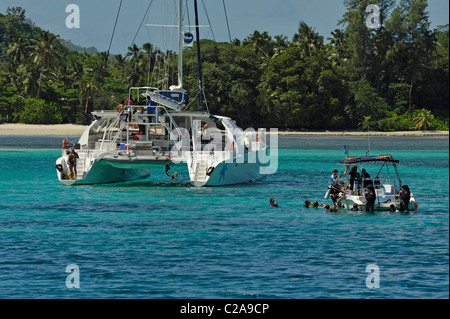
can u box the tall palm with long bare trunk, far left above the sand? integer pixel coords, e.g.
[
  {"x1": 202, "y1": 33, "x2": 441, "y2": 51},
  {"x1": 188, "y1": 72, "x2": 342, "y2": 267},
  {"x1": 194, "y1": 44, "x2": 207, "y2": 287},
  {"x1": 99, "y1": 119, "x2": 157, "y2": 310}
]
[{"x1": 31, "y1": 31, "x2": 62, "y2": 99}]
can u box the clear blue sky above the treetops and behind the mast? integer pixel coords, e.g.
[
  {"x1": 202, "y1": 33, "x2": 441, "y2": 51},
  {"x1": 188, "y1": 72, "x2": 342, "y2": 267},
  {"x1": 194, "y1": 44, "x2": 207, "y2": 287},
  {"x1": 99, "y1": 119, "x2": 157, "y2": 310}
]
[{"x1": 0, "y1": 0, "x2": 449, "y2": 54}]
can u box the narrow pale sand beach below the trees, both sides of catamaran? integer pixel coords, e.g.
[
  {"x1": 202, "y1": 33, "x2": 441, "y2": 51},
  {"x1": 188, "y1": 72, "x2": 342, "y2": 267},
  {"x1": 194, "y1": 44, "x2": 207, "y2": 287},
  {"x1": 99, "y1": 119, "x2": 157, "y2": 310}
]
[{"x1": 0, "y1": 123, "x2": 449, "y2": 137}]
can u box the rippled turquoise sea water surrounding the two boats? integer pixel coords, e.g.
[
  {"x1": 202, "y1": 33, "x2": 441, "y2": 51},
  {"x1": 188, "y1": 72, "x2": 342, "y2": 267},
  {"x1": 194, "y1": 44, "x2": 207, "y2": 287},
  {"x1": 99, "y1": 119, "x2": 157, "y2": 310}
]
[{"x1": 0, "y1": 137, "x2": 449, "y2": 299}]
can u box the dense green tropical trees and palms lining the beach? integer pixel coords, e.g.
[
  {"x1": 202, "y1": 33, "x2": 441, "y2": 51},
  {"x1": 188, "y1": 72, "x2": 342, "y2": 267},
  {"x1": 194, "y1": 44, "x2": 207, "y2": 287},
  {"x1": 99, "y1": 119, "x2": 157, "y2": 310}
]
[{"x1": 0, "y1": 0, "x2": 449, "y2": 131}]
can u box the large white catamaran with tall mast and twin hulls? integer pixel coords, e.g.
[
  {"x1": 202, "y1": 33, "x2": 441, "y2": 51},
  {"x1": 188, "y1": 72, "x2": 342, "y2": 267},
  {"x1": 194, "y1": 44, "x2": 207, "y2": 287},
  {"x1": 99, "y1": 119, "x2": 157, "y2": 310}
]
[{"x1": 56, "y1": 0, "x2": 276, "y2": 186}]
